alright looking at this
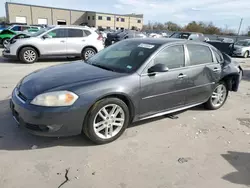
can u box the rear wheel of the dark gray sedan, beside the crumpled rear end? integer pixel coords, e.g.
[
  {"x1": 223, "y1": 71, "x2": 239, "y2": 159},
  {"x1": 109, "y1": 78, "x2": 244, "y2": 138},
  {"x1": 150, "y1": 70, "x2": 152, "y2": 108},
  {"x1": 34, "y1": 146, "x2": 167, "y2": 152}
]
[{"x1": 205, "y1": 82, "x2": 228, "y2": 110}]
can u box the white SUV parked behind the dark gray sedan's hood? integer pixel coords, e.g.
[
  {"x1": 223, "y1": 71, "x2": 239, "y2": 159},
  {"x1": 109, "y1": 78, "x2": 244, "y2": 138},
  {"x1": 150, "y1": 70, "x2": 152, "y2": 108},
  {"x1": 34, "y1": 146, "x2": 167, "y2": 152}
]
[{"x1": 3, "y1": 26, "x2": 104, "y2": 63}]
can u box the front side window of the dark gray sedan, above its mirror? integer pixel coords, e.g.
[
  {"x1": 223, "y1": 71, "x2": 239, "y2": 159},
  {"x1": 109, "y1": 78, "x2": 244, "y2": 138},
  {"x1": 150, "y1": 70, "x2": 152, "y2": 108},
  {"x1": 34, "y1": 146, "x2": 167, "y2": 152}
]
[{"x1": 154, "y1": 45, "x2": 185, "y2": 69}]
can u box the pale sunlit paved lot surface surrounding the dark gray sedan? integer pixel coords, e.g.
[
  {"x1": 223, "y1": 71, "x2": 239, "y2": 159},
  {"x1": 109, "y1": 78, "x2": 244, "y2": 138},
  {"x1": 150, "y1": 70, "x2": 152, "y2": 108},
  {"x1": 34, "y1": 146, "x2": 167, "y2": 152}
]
[{"x1": 0, "y1": 49, "x2": 250, "y2": 188}]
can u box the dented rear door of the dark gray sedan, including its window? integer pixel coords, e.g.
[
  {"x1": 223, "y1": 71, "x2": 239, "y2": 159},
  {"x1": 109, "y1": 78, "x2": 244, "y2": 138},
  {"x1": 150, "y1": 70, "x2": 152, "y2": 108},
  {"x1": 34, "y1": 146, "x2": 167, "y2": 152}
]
[{"x1": 185, "y1": 44, "x2": 221, "y2": 105}]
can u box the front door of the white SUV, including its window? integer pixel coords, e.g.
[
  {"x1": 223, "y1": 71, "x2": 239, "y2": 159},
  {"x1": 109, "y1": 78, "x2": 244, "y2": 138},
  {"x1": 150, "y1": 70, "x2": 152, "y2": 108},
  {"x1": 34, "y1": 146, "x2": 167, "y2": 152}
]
[{"x1": 39, "y1": 28, "x2": 67, "y2": 56}]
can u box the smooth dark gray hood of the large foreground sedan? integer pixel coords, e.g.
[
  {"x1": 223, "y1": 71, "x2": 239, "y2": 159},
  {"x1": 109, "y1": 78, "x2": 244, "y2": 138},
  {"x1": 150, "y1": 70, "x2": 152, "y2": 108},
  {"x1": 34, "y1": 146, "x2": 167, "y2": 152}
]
[{"x1": 18, "y1": 61, "x2": 122, "y2": 100}]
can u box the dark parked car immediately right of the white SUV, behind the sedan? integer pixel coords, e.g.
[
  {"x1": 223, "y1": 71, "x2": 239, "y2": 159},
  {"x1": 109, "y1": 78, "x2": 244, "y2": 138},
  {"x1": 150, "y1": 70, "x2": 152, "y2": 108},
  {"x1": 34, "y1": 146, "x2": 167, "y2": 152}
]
[{"x1": 105, "y1": 30, "x2": 146, "y2": 47}]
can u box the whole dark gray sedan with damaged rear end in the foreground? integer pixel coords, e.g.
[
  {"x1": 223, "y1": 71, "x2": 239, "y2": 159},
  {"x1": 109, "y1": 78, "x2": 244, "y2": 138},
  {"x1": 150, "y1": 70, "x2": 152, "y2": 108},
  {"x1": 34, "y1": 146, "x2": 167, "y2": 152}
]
[{"x1": 10, "y1": 39, "x2": 242, "y2": 144}]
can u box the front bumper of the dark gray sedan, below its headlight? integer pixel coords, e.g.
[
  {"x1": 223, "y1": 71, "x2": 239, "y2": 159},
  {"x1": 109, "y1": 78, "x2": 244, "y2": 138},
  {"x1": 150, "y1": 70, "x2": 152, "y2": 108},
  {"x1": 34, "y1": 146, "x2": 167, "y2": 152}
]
[{"x1": 10, "y1": 89, "x2": 86, "y2": 137}]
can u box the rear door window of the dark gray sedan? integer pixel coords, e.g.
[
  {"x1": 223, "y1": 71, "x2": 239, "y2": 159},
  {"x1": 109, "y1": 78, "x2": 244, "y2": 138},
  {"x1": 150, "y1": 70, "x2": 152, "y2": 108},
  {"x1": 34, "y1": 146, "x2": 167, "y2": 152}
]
[{"x1": 187, "y1": 44, "x2": 213, "y2": 65}]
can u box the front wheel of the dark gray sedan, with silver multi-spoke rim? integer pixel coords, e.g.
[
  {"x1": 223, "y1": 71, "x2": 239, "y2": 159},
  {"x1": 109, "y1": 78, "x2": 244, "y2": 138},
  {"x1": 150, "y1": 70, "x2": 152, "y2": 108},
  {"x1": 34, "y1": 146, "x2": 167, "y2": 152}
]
[{"x1": 83, "y1": 98, "x2": 130, "y2": 144}]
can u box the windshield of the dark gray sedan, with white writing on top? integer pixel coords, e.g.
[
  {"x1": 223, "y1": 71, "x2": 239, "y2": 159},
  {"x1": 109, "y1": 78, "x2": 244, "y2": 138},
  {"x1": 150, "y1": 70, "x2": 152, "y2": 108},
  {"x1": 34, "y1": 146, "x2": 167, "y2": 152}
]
[{"x1": 87, "y1": 40, "x2": 160, "y2": 73}]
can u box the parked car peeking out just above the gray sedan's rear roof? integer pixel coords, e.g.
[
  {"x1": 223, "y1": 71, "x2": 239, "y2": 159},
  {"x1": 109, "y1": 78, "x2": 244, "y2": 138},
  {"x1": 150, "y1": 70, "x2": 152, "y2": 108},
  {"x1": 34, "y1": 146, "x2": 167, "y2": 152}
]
[{"x1": 169, "y1": 32, "x2": 206, "y2": 42}]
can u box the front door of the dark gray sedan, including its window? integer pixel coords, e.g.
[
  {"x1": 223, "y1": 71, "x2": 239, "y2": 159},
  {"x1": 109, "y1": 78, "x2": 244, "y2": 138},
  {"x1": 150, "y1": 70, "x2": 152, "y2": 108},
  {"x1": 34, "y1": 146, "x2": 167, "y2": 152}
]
[{"x1": 140, "y1": 45, "x2": 188, "y2": 118}]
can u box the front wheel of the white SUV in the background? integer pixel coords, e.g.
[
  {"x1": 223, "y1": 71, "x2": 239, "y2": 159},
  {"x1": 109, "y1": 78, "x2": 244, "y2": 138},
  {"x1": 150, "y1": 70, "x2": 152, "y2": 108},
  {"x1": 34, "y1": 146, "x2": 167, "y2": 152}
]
[{"x1": 19, "y1": 47, "x2": 38, "y2": 64}]
